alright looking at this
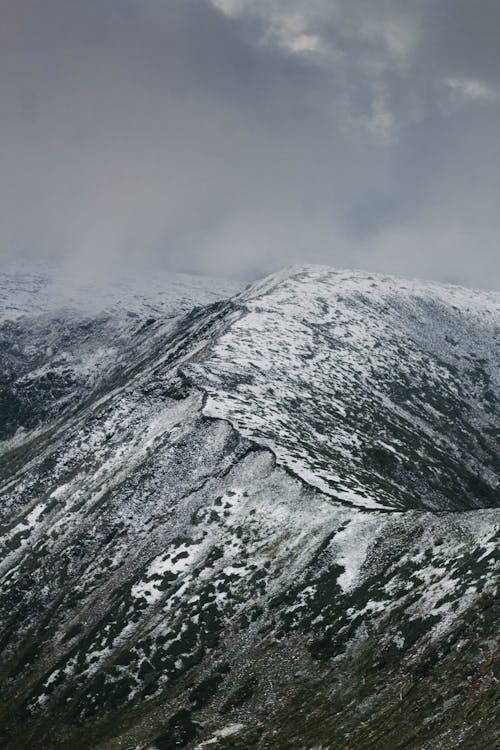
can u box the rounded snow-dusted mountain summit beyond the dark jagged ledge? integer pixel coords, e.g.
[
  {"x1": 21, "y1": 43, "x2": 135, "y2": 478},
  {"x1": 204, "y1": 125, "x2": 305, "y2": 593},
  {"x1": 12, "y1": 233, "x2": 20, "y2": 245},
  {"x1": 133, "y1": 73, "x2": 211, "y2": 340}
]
[{"x1": 187, "y1": 266, "x2": 500, "y2": 509}]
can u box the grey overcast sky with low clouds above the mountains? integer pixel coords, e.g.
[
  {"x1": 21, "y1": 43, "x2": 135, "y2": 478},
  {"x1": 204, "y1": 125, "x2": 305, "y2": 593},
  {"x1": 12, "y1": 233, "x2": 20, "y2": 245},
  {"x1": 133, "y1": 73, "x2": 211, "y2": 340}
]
[{"x1": 0, "y1": 0, "x2": 500, "y2": 289}]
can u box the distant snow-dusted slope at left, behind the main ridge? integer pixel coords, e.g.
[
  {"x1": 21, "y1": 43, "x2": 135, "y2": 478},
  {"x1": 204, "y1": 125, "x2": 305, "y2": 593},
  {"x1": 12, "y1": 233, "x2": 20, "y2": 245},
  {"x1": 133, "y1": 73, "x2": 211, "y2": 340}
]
[{"x1": 0, "y1": 266, "x2": 241, "y2": 441}]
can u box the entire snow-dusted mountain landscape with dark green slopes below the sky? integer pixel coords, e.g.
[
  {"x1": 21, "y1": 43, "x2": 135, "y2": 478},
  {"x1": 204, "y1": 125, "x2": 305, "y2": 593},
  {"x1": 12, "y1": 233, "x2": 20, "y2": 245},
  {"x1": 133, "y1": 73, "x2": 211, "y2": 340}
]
[{"x1": 0, "y1": 266, "x2": 500, "y2": 750}]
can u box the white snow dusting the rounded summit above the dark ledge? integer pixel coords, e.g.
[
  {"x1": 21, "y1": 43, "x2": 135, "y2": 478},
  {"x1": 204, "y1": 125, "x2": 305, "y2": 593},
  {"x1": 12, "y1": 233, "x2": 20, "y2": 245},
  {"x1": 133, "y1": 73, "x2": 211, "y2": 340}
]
[{"x1": 186, "y1": 266, "x2": 500, "y2": 510}]
